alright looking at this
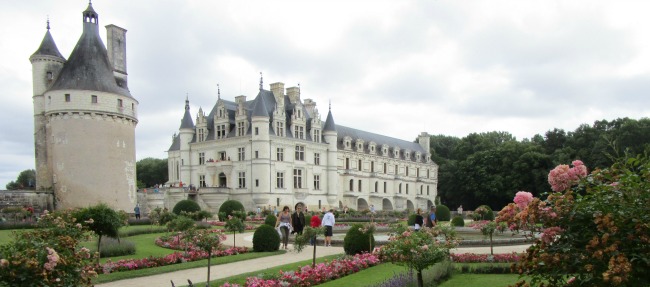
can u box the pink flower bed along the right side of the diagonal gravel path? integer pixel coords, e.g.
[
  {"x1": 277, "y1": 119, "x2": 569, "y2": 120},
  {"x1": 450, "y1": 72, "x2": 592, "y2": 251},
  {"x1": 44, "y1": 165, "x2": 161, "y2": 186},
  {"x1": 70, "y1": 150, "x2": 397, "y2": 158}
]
[{"x1": 221, "y1": 253, "x2": 380, "y2": 287}]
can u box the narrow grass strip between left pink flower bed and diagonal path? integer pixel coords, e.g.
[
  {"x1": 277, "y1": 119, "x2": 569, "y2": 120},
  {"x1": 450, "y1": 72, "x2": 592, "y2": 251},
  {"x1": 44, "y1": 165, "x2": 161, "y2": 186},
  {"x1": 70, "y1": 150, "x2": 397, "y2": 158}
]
[{"x1": 93, "y1": 251, "x2": 286, "y2": 284}]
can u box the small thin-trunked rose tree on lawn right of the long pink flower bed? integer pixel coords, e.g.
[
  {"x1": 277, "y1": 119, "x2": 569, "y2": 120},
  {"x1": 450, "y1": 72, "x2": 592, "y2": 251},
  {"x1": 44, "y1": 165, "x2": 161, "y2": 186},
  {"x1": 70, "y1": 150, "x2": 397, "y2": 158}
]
[{"x1": 379, "y1": 225, "x2": 457, "y2": 287}]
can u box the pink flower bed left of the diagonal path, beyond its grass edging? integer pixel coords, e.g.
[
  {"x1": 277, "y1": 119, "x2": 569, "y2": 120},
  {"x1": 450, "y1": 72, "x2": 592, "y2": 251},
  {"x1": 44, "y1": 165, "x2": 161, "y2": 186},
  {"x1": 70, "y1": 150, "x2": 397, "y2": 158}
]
[{"x1": 96, "y1": 247, "x2": 248, "y2": 274}]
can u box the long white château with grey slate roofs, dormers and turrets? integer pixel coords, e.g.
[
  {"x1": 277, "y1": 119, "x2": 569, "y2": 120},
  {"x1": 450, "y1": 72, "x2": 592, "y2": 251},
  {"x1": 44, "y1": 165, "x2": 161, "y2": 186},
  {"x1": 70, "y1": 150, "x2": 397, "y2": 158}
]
[{"x1": 168, "y1": 79, "x2": 438, "y2": 213}]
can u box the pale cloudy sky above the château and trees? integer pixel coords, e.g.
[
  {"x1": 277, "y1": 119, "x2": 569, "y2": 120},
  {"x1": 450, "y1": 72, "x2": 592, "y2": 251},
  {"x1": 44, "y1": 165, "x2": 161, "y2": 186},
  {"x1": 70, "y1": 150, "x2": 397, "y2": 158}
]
[{"x1": 0, "y1": 0, "x2": 650, "y2": 188}]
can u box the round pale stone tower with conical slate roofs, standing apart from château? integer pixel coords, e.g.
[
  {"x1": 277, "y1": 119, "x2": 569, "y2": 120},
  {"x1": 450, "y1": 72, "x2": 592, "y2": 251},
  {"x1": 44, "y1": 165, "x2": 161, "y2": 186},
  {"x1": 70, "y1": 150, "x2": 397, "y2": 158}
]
[{"x1": 29, "y1": 4, "x2": 138, "y2": 211}]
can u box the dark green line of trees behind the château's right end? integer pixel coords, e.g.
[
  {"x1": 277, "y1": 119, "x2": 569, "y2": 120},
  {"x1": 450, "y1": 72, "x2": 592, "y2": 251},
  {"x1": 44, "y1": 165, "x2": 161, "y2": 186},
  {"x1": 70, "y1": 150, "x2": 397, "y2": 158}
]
[{"x1": 431, "y1": 118, "x2": 650, "y2": 210}]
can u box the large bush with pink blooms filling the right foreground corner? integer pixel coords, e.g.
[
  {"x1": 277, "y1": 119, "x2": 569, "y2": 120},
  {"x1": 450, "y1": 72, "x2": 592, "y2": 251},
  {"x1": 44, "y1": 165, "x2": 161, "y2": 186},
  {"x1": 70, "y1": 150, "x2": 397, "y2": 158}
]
[{"x1": 498, "y1": 156, "x2": 650, "y2": 286}]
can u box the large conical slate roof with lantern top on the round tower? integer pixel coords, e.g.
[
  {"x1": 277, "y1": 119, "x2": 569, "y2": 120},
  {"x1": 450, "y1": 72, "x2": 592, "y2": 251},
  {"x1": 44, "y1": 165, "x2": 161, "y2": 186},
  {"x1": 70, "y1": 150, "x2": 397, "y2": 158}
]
[{"x1": 46, "y1": 5, "x2": 132, "y2": 97}]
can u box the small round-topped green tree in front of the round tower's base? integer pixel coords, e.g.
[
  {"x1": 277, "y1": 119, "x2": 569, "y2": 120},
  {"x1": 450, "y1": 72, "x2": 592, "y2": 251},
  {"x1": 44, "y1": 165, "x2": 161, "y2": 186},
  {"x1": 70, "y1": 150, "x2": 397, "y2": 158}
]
[{"x1": 74, "y1": 203, "x2": 125, "y2": 264}]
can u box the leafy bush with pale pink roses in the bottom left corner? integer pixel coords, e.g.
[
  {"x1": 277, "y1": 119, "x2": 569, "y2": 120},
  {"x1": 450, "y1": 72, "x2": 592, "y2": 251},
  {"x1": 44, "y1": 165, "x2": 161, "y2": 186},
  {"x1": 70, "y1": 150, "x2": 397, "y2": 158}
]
[{"x1": 0, "y1": 211, "x2": 95, "y2": 287}]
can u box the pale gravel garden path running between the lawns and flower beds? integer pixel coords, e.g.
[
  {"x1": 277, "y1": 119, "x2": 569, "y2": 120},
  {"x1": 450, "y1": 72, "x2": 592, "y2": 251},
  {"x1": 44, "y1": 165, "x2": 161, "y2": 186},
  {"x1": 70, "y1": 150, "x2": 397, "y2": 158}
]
[{"x1": 95, "y1": 233, "x2": 528, "y2": 287}]
